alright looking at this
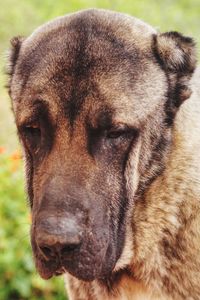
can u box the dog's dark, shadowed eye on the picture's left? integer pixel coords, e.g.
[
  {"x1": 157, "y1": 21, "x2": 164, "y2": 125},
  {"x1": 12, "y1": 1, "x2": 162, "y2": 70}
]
[{"x1": 22, "y1": 125, "x2": 41, "y2": 152}]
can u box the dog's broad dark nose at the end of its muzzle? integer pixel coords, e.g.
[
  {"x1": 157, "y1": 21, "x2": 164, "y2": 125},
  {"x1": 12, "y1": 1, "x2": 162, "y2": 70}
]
[{"x1": 36, "y1": 216, "x2": 82, "y2": 259}]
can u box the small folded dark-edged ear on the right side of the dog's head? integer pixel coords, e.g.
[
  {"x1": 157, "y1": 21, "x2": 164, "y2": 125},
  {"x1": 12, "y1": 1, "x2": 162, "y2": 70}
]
[{"x1": 154, "y1": 31, "x2": 197, "y2": 108}]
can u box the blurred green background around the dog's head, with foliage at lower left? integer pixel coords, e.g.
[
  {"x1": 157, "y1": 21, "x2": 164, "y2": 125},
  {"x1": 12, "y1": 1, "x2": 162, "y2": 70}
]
[{"x1": 0, "y1": 0, "x2": 200, "y2": 300}]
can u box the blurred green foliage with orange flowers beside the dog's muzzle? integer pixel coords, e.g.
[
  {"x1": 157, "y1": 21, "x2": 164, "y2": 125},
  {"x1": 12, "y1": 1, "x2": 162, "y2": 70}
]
[{"x1": 0, "y1": 148, "x2": 66, "y2": 300}]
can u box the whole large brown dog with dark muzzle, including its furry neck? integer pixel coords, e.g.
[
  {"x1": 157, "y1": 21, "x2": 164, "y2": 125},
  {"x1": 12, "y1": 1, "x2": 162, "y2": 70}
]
[{"x1": 8, "y1": 9, "x2": 200, "y2": 300}]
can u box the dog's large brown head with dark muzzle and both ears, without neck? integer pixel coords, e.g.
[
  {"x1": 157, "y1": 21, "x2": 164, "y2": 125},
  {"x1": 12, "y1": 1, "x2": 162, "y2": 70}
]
[{"x1": 9, "y1": 10, "x2": 195, "y2": 280}]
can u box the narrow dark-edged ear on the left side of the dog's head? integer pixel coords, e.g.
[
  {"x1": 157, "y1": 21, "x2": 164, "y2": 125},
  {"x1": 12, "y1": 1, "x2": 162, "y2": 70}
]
[{"x1": 6, "y1": 36, "x2": 24, "y2": 94}]
